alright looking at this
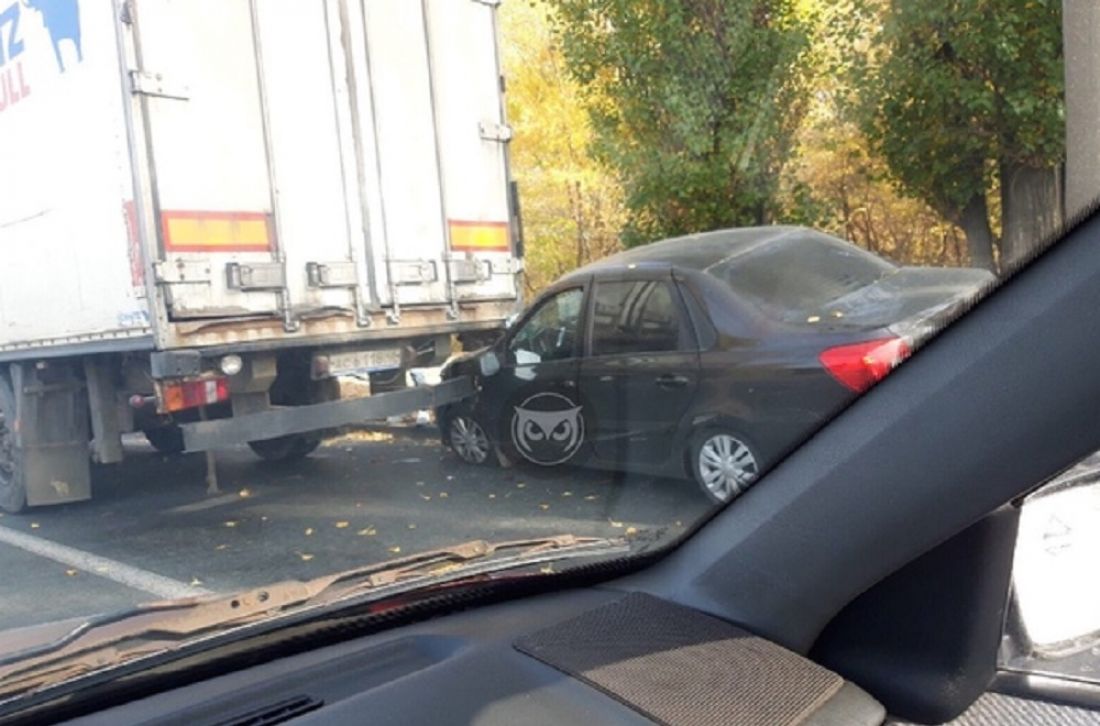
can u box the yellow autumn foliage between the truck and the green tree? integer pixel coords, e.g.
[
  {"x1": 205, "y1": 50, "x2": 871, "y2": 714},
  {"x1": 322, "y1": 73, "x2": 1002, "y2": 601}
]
[{"x1": 501, "y1": 0, "x2": 624, "y2": 293}]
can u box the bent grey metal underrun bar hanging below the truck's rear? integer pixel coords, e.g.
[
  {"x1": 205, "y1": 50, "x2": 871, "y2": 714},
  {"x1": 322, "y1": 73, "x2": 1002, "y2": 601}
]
[{"x1": 179, "y1": 376, "x2": 474, "y2": 451}]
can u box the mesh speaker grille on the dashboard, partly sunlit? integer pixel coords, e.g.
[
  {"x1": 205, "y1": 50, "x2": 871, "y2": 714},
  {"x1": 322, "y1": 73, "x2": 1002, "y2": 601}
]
[{"x1": 515, "y1": 594, "x2": 844, "y2": 726}]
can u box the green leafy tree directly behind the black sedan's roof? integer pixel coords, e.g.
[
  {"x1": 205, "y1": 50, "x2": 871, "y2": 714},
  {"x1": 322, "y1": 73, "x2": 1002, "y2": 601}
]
[{"x1": 553, "y1": 0, "x2": 811, "y2": 245}]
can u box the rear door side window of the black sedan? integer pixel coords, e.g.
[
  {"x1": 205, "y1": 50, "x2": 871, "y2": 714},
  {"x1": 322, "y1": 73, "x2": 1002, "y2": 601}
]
[{"x1": 592, "y1": 279, "x2": 692, "y2": 355}]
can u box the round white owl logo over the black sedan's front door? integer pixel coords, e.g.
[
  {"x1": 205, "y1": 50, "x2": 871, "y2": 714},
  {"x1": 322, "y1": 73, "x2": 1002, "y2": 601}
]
[{"x1": 512, "y1": 393, "x2": 584, "y2": 466}]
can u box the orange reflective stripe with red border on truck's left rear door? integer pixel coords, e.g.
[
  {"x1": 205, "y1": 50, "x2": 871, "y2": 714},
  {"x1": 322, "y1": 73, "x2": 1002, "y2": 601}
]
[{"x1": 161, "y1": 211, "x2": 274, "y2": 252}]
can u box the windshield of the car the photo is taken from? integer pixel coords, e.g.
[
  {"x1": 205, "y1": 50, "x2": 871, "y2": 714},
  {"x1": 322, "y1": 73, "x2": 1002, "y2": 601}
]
[{"x1": 0, "y1": 0, "x2": 1100, "y2": 701}]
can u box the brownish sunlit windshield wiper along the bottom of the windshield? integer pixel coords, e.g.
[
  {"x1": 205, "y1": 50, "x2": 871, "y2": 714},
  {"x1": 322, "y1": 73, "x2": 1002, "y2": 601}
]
[{"x1": 0, "y1": 535, "x2": 629, "y2": 700}]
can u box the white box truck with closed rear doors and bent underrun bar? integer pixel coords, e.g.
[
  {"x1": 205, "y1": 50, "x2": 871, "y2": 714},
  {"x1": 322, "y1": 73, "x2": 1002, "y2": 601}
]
[{"x1": 0, "y1": 0, "x2": 523, "y2": 512}]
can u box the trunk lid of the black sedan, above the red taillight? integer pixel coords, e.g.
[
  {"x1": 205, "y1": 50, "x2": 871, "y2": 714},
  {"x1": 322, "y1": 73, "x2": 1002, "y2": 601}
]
[{"x1": 820, "y1": 267, "x2": 996, "y2": 329}]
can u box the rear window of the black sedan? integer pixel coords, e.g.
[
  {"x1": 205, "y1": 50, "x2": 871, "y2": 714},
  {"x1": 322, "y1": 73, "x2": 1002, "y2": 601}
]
[{"x1": 707, "y1": 234, "x2": 897, "y2": 319}]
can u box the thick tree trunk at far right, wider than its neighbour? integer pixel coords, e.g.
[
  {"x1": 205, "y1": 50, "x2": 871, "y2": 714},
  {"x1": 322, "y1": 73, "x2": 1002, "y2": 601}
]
[{"x1": 1001, "y1": 163, "x2": 1062, "y2": 270}]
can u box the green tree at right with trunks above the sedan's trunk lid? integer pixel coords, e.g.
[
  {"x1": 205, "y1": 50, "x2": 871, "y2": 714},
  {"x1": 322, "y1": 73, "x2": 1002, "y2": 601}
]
[{"x1": 848, "y1": 0, "x2": 1065, "y2": 268}]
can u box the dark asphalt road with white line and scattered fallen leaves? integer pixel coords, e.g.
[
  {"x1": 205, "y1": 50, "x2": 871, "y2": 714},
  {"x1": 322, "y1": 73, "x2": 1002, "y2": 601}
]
[{"x1": 0, "y1": 427, "x2": 708, "y2": 629}]
